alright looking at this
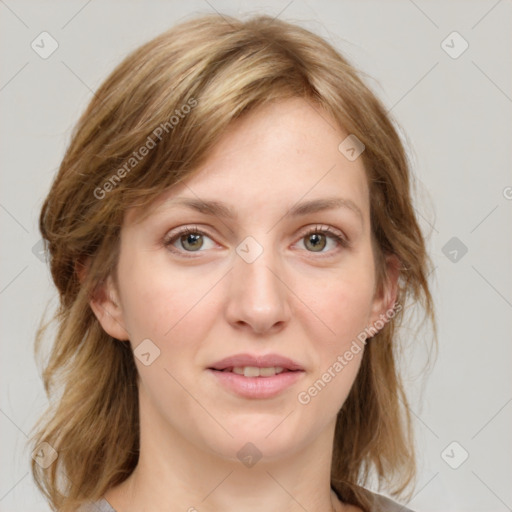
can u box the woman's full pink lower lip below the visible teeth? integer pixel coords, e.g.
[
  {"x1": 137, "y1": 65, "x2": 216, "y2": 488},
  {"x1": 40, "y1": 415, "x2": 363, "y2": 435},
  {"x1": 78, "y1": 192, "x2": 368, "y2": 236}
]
[{"x1": 208, "y1": 369, "x2": 304, "y2": 398}]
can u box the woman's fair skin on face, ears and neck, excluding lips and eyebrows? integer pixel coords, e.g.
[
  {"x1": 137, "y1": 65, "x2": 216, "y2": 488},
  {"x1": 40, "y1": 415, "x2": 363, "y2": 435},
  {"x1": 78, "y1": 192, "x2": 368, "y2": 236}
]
[{"x1": 91, "y1": 98, "x2": 398, "y2": 512}]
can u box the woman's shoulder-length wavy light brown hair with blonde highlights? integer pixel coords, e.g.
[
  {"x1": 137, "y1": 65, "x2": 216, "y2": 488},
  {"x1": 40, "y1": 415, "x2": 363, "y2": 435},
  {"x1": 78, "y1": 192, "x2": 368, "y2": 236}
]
[{"x1": 30, "y1": 14, "x2": 437, "y2": 512}]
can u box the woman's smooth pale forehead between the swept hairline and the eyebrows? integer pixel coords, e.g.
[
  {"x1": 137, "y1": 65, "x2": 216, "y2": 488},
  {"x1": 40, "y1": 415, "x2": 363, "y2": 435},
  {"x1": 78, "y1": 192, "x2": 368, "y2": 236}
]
[{"x1": 126, "y1": 98, "x2": 369, "y2": 228}]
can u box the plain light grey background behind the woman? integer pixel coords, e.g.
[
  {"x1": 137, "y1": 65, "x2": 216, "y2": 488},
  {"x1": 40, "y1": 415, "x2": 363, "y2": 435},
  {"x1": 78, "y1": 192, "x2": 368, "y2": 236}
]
[{"x1": 0, "y1": 0, "x2": 512, "y2": 512}]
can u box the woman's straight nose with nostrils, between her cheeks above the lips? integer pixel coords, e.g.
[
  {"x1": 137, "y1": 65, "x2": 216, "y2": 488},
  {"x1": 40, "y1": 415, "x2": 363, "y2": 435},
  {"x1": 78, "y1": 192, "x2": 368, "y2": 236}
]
[{"x1": 226, "y1": 240, "x2": 292, "y2": 334}]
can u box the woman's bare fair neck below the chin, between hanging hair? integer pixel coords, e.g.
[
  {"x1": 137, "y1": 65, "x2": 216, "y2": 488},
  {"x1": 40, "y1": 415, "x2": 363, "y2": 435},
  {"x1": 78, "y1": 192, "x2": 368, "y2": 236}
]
[{"x1": 105, "y1": 392, "x2": 349, "y2": 512}]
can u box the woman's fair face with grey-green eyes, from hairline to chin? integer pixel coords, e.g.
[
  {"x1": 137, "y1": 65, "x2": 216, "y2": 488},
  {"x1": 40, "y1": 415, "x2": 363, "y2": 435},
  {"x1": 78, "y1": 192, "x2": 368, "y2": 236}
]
[{"x1": 94, "y1": 99, "x2": 394, "y2": 459}]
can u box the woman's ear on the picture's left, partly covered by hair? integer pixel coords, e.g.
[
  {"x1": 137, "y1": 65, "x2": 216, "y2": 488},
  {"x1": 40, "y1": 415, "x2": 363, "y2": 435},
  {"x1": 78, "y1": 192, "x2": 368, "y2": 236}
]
[{"x1": 75, "y1": 259, "x2": 130, "y2": 341}]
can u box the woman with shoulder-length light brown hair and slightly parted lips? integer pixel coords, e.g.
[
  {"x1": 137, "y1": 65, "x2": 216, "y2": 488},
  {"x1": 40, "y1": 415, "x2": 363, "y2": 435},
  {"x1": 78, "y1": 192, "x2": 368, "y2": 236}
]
[{"x1": 28, "y1": 15, "x2": 435, "y2": 512}]
